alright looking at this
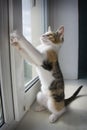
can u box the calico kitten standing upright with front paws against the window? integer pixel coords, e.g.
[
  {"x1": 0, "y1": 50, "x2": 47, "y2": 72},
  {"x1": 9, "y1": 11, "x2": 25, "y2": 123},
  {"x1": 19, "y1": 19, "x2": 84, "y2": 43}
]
[{"x1": 10, "y1": 26, "x2": 82, "y2": 123}]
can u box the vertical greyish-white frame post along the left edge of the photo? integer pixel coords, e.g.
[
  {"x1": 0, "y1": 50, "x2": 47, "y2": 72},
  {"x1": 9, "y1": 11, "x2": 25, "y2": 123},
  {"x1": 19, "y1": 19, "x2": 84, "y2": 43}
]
[{"x1": 0, "y1": 0, "x2": 14, "y2": 130}]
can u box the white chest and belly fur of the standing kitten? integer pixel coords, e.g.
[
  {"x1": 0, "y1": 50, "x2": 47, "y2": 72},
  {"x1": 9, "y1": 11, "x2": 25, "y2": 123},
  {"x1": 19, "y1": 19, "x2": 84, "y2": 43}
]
[{"x1": 37, "y1": 45, "x2": 54, "y2": 92}]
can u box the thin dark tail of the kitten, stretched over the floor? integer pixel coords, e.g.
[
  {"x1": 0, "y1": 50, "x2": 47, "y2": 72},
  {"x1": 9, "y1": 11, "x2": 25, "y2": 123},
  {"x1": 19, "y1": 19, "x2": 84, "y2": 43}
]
[{"x1": 65, "y1": 86, "x2": 83, "y2": 106}]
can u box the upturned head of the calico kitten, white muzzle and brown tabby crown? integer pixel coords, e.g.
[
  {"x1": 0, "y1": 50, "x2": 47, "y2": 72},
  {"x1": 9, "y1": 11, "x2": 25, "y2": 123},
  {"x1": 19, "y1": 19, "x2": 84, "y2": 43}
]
[{"x1": 40, "y1": 26, "x2": 64, "y2": 46}]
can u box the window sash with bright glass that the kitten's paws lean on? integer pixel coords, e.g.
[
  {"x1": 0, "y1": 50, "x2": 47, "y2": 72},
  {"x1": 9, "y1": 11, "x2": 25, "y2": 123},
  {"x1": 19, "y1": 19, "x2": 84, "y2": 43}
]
[{"x1": 9, "y1": 0, "x2": 47, "y2": 121}]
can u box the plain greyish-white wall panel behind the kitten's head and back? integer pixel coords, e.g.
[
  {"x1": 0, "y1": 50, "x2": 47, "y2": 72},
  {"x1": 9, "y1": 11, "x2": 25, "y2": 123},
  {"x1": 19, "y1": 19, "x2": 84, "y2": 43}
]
[{"x1": 48, "y1": 0, "x2": 78, "y2": 79}]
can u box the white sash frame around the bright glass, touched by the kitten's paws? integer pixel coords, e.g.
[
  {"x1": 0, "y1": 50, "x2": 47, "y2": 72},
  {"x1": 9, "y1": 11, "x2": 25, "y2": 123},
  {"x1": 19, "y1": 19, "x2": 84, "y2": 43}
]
[{"x1": 9, "y1": 0, "x2": 47, "y2": 121}]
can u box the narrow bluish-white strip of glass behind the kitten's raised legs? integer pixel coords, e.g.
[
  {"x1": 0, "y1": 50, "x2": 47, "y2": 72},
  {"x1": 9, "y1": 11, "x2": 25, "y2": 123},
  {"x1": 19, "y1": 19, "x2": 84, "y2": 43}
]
[{"x1": 22, "y1": 0, "x2": 32, "y2": 84}]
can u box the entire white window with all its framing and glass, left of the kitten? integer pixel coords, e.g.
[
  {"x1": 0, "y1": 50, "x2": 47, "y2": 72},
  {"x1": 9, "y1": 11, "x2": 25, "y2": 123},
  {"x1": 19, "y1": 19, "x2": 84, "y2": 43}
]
[{"x1": 0, "y1": 0, "x2": 47, "y2": 129}]
